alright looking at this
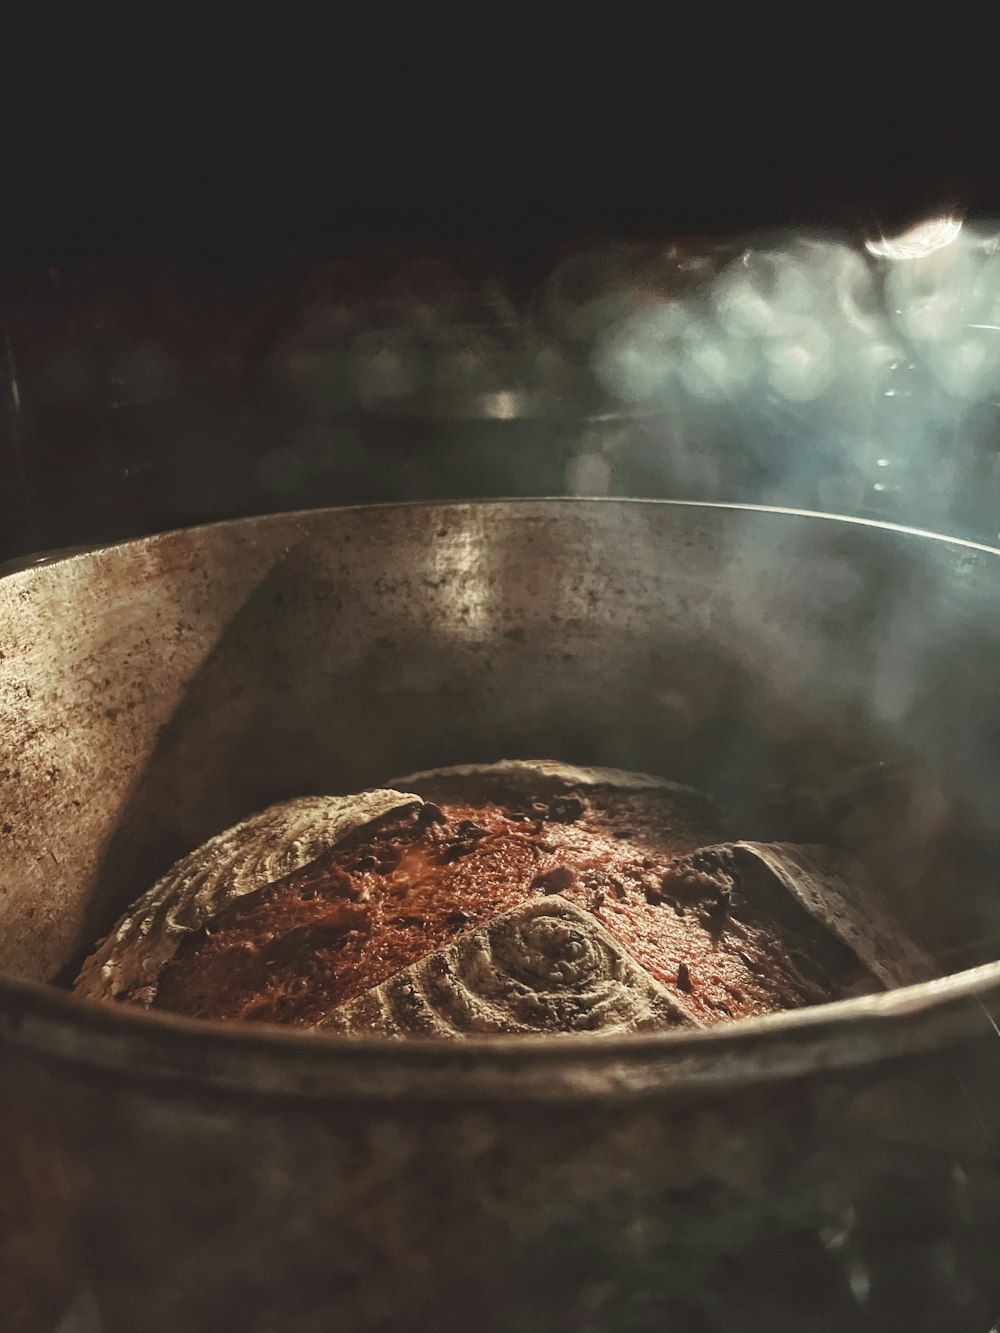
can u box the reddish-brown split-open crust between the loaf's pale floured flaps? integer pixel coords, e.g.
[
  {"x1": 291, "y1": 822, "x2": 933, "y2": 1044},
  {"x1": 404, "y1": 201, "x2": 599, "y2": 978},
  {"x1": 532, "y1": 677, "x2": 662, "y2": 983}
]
[{"x1": 129, "y1": 780, "x2": 906, "y2": 1025}]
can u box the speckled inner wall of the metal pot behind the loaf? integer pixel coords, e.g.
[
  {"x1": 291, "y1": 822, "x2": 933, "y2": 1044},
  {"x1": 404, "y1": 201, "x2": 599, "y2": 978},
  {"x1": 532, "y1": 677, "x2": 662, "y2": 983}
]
[{"x1": 0, "y1": 501, "x2": 1000, "y2": 980}]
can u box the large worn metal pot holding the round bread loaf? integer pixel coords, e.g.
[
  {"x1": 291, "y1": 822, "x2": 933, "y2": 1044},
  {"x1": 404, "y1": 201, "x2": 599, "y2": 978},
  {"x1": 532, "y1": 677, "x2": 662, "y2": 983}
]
[{"x1": 0, "y1": 500, "x2": 1000, "y2": 1333}]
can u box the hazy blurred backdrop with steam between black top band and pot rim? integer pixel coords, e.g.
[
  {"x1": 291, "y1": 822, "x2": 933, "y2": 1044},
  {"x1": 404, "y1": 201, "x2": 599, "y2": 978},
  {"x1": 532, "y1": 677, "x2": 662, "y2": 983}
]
[{"x1": 7, "y1": 215, "x2": 1000, "y2": 559}]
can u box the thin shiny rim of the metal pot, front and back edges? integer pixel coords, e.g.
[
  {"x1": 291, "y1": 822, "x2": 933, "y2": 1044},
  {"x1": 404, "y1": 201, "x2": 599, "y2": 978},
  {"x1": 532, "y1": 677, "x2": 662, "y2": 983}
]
[{"x1": 0, "y1": 496, "x2": 1000, "y2": 1100}]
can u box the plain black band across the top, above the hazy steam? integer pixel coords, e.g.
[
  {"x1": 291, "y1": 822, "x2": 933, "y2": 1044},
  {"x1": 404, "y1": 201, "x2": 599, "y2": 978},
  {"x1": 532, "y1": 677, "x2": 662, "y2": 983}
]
[{"x1": 0, "y1": 3, "x2": 1000, "y2": 261}]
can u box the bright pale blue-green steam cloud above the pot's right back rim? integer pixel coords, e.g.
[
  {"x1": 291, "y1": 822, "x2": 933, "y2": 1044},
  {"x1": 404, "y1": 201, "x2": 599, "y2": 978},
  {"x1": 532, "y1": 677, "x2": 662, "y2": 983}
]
[{"x1": 592, "y1": 216, "x2": 1000, "y2": 537}]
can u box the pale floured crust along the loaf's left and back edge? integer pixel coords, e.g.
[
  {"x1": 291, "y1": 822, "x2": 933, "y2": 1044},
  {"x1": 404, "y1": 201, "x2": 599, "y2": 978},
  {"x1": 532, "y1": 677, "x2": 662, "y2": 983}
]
[{"x1": 73, "y1": 760, "x2": 708, "y2": 1008}]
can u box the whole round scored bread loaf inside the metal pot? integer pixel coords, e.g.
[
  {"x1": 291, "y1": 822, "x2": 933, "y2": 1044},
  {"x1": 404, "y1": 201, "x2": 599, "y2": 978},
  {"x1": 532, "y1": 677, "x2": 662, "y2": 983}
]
[{"x1": 75, "y1": 761, "x2": 927, "y2": 1037}]
